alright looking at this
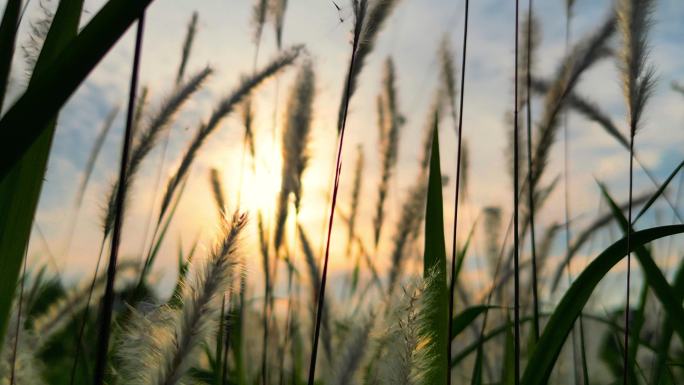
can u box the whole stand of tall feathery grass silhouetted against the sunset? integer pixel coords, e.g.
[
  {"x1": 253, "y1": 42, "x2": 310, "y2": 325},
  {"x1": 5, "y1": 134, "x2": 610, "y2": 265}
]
[{"x1": 0, "y1": 0, "x2": 684, "y2": 385}]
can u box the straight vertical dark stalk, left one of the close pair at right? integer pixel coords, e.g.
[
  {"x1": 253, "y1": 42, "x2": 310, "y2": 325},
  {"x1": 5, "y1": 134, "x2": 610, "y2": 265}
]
[{"x1": 513, "y1": 0, "x2": 520, "y2": 385}]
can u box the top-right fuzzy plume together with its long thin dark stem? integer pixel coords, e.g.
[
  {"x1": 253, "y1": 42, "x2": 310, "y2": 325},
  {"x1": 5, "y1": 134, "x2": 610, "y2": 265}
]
[{"x1": 617, "y1": 0, "x2": 655, "y2": 372}]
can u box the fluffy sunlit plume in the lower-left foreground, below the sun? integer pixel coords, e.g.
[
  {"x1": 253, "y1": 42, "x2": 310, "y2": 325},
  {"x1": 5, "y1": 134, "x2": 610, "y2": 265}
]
[{"x1": 117, "y1": 213, "x2": 247, "y2": 385}]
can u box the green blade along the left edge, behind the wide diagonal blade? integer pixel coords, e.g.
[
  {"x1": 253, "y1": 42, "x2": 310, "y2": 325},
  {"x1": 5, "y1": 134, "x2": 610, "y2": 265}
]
[{"x1": 0, "y1": 0, "x2": 83, "y2": 343}]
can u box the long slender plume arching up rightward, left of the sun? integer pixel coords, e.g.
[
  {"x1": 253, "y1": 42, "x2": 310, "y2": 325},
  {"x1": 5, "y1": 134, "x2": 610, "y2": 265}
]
[{"x1": 158, "y1": 46, "x2": 304, "y2": 223}]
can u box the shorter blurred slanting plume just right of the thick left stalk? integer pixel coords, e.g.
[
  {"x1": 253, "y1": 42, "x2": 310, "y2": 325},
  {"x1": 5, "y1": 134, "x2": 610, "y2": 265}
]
[{"x1": 103, "y1": 67, "x2": 212, "y2": 237}]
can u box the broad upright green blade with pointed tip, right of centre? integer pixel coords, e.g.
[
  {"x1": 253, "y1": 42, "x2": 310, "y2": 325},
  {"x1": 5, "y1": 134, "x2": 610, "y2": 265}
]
[{"x1": 423, "y1": 127, "x2": 449, "y2": 385}]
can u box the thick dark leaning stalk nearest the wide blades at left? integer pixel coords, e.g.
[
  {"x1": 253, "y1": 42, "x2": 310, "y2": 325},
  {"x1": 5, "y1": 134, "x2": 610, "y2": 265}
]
[{"x1": 93, "y1": 10, "x2": 145, "y2": 385}]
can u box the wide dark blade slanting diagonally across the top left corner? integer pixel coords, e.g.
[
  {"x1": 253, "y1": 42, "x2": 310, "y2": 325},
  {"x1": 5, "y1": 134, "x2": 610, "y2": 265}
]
[{"x1": 0, "y1": 0, "x2": 152, "y2": 179}]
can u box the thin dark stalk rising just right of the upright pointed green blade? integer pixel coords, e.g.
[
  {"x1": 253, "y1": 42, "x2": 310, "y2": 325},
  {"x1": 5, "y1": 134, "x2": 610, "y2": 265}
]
[{"x1": 446, "y1": 0, "x2": 470, "y2": 385}]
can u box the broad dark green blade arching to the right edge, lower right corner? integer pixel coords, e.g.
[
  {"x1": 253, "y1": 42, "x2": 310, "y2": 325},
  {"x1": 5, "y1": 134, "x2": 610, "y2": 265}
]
[{"x1": 521, "y1": 225, "x2": 684, "y2": 385}]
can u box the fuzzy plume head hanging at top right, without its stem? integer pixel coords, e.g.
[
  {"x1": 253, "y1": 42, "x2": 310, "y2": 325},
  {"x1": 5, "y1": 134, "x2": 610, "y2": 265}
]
[{"x1": 617, "y1": 0, "x2": 655, "y2": 136}]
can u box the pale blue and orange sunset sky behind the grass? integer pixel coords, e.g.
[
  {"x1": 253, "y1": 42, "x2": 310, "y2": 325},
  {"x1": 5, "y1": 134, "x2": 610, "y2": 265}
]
[{"x1": 6, "y1": 0, "x2": 684, "y2": 306}]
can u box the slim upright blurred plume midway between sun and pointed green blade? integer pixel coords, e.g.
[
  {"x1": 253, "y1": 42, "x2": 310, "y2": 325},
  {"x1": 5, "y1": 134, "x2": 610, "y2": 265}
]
[{"x1": 373, "y1": 57, "x2": 403, "y2": 249}]
